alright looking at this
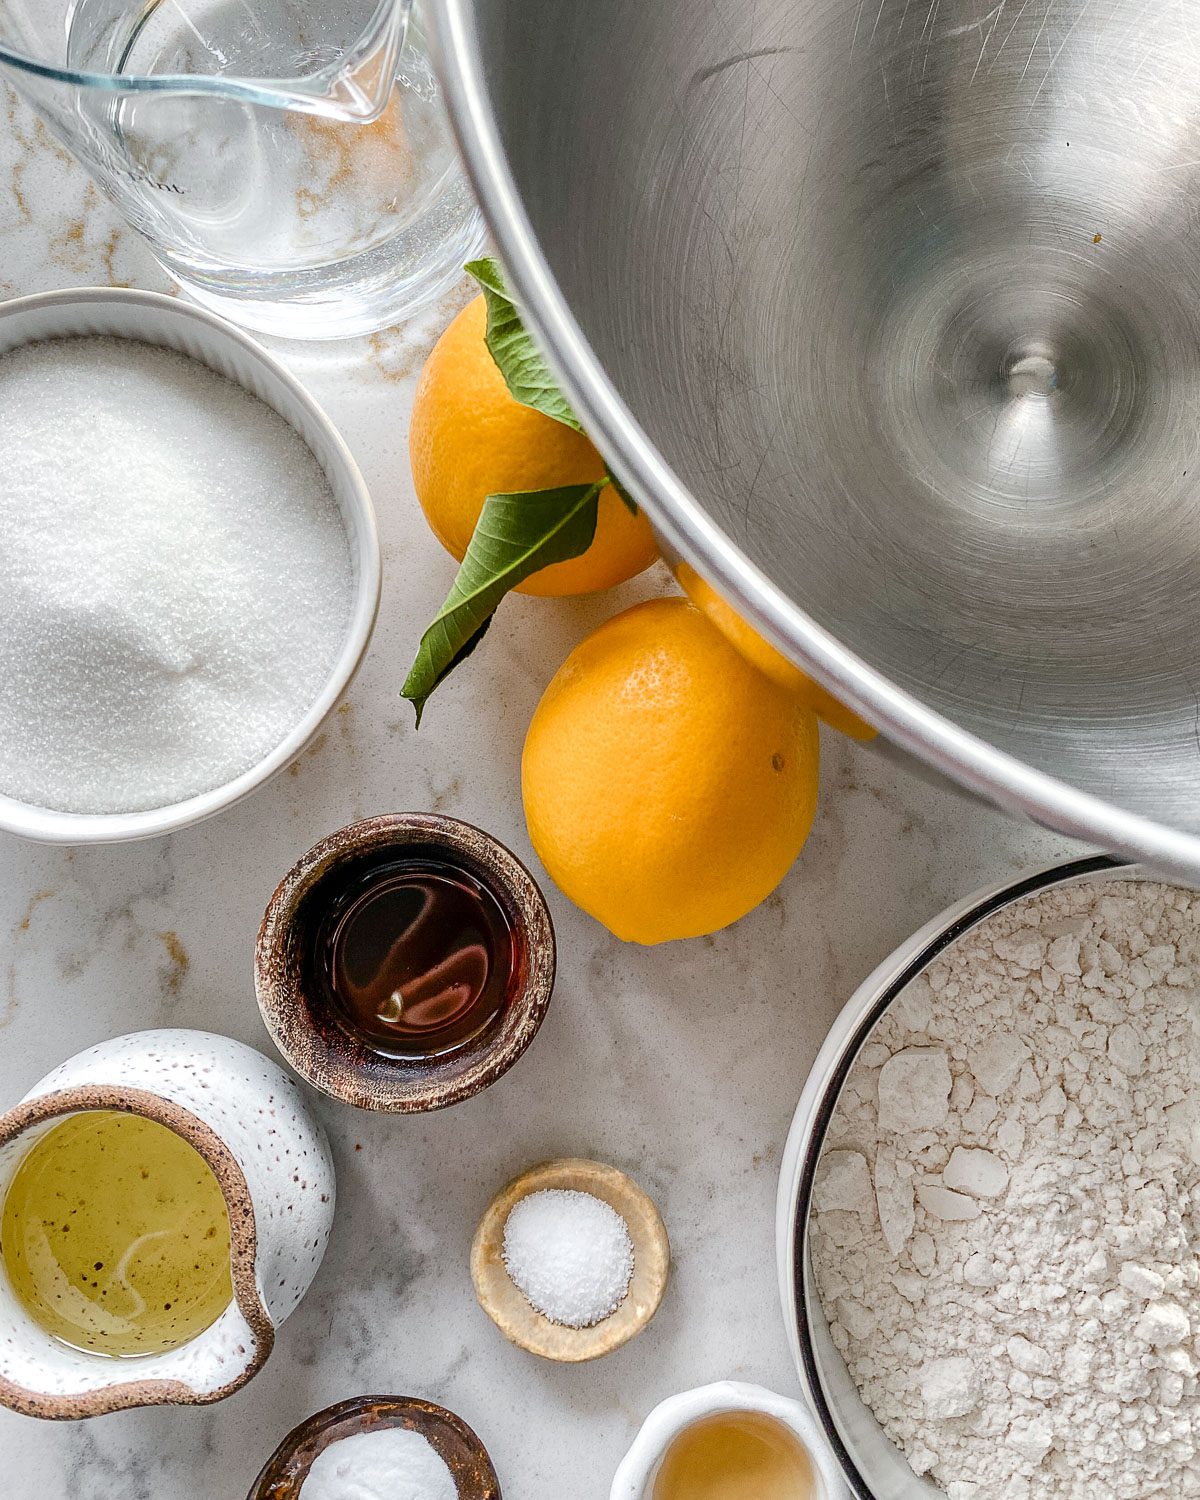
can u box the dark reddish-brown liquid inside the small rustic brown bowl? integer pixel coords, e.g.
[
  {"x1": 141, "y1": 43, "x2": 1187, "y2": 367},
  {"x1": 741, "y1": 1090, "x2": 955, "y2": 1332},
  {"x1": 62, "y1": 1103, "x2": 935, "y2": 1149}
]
[{"x1": 314, "y1": 852, "x2": 516, "y2": 1061}]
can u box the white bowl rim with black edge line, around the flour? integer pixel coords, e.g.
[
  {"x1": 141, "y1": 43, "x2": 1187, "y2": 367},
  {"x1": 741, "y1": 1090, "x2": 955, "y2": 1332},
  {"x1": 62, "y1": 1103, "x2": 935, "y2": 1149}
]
[{"x1": 776, "y1": 854, "x2": 1140, "y2": 1500}]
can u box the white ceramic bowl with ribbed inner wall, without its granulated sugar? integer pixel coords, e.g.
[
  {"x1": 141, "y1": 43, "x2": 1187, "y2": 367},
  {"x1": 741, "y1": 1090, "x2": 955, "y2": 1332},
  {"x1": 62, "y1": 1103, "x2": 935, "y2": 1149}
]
[{"x1": 0, "y1": 288, "x2": 381, "y2": 845}]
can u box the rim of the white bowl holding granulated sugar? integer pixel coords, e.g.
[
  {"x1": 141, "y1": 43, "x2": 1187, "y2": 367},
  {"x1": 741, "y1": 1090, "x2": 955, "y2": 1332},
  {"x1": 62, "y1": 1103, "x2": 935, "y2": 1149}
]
[{"x1": 0, "y1": 287, "x2": 383, "y2": 845}]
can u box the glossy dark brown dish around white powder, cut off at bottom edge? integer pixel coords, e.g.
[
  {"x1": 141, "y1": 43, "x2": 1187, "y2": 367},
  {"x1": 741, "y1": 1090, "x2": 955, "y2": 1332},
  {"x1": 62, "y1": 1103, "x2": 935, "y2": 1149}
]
[{"x1": 246, "y1": 1397, "x2": 501, "y2": 1500}]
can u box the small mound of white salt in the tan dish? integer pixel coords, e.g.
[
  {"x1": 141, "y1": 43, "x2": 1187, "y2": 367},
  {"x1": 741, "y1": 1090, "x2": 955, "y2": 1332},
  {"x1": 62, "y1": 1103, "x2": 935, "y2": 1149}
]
[{"x1": 504, "y1": 1188, "x2": 633, "y2": 1328}]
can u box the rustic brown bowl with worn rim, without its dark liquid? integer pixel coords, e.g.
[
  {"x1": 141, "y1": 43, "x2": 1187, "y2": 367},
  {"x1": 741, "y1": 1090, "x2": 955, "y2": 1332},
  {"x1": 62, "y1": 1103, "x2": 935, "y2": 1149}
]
[{"x1": 255, "y1": 813, "x2": 555, "y2": 1113}]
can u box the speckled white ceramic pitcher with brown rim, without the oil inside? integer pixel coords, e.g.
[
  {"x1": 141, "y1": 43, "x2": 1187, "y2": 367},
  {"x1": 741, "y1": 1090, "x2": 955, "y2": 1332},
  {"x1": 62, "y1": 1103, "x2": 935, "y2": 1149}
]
[{"x1": 0, "y1": 1031, "x2": 333, "y2": 1418}]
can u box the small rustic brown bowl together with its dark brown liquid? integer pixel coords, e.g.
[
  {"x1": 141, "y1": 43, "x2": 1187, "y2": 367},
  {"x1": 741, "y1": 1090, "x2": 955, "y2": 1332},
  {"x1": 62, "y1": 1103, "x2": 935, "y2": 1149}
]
[{"x1": 255, "y1": 813, "x2": 555, "y2": 1113}]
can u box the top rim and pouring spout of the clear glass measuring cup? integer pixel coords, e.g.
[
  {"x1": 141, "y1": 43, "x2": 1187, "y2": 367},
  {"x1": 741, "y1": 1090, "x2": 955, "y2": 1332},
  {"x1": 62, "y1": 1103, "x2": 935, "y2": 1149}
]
[{"x1": 0, "y1": 0, "x2": 413, "y2": 125}]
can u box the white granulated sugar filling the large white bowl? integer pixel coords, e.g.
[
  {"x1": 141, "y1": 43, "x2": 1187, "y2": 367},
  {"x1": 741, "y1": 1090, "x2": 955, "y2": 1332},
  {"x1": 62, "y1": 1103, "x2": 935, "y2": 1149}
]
[{"x1": 0, "y1": 338, "x2": 353, "y2": 813}]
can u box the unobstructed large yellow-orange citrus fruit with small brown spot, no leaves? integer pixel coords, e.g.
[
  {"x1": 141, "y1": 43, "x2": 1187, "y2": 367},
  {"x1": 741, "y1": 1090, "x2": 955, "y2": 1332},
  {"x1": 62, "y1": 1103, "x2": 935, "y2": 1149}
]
[{"x1": 521, "y1": 599, "x2": 818, "y2": 944}]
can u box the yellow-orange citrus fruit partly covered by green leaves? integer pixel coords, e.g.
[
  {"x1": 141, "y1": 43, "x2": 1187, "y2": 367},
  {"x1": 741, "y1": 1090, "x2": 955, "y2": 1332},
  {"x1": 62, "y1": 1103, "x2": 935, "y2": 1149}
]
[{"x1": 408, "y1": 297, "x2": 659, "y2": 594}]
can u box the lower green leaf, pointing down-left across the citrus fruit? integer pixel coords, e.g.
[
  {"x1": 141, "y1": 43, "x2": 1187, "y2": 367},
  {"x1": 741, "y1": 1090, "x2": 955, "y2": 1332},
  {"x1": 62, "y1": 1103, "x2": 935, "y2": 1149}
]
[{"x1": 401, "y1": 479, "x2": 606, "y2": 728}]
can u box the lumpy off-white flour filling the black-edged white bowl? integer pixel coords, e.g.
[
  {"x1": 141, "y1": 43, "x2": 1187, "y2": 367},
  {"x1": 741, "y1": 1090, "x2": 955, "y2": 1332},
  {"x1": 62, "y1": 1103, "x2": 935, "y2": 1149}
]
[{"x1": 812, "y1": 882, "x2": 1200, "y2": 1500}]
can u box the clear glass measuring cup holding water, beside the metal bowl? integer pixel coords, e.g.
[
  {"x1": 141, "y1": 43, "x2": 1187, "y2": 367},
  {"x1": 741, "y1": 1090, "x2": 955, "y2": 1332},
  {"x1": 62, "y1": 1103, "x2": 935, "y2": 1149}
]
[{"x1": 0, "y1": 0, "x2": 483, "y2": 339}]
